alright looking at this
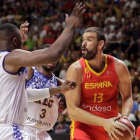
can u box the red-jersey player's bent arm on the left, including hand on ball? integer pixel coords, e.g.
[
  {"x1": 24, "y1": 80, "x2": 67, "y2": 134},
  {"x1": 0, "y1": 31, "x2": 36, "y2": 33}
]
[{"x1": 65, "y1": 62, "x2": 124, "y2": 137}]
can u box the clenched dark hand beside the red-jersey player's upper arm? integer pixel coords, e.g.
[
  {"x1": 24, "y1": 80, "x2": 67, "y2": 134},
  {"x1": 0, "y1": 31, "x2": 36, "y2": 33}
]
[{"x1": 60, "y1": 80, "x2": 77, "y2": 93}]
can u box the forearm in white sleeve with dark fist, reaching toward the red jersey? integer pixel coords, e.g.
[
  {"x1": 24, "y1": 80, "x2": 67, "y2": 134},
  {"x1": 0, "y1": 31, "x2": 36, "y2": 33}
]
[{"x1": 27, "y1": 80, "x2": 76, "y2": 102}]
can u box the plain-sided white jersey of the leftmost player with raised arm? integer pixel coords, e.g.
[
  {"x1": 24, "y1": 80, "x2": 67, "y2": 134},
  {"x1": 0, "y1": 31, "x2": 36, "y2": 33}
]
[{"x1": 0, "y1": 52, "x2": 27, "y2": 125}]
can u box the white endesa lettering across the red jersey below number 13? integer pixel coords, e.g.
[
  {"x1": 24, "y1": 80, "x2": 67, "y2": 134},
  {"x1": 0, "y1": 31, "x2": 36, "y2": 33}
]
[{"x1": 81, "y1": 104, "x2": 111, "y2": 112}]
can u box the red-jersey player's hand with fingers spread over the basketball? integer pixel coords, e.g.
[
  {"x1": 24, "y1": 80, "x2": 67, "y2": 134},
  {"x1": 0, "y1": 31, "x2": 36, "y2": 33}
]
[{"x1": 103, "y1": 116, "x2": 126, "y2": 140}]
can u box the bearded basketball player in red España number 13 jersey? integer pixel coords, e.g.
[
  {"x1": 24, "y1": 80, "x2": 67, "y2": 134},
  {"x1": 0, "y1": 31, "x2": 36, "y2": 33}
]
[{"x1": 65, "y1": 27, "x2": 133, "y2": 140}]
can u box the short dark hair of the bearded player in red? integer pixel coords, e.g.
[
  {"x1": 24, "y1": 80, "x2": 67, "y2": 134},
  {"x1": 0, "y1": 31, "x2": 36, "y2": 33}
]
[{"x1": 85, "y1": 27, "x2": 106, "y2": 48}]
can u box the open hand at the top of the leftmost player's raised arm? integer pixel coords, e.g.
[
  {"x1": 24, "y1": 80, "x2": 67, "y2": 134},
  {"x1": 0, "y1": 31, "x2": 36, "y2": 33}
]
[{"x1": 65, "y1": 3, "x2": 86, "y2": 29}]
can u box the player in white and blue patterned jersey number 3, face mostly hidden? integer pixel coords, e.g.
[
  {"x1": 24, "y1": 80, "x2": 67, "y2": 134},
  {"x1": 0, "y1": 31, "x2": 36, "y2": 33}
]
[{"x1": 25, "y1": 44, "x2": 66, "y2": 140}]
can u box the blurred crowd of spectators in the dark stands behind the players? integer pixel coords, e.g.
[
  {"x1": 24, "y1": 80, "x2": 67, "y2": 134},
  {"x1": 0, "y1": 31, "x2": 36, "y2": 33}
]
[{"x1": 0, "y1": 0, "x2": 140, "y2": 138}]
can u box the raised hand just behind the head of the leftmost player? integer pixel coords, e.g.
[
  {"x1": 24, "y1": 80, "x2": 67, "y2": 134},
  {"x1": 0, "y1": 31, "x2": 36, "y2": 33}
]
[{"x1": 20, "y1": 21, "x2": 29, "y2": 43}]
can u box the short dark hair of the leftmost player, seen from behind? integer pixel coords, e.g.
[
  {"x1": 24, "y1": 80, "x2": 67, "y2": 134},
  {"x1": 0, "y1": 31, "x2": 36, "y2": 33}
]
[{"x1": 0, "y1": 23, "x2": 18, "y2": 40}]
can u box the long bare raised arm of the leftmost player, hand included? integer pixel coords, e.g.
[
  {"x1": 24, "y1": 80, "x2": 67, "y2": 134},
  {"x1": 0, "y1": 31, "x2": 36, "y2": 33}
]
[{"x1": 4, "y1": 4, "x2": 85, "y2": 72}]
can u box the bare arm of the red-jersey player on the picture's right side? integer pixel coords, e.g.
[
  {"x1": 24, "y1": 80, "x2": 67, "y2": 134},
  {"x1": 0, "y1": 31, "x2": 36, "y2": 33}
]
[{"x1": 115, "y1": 59, "x2": 133, "y2": 116}]
